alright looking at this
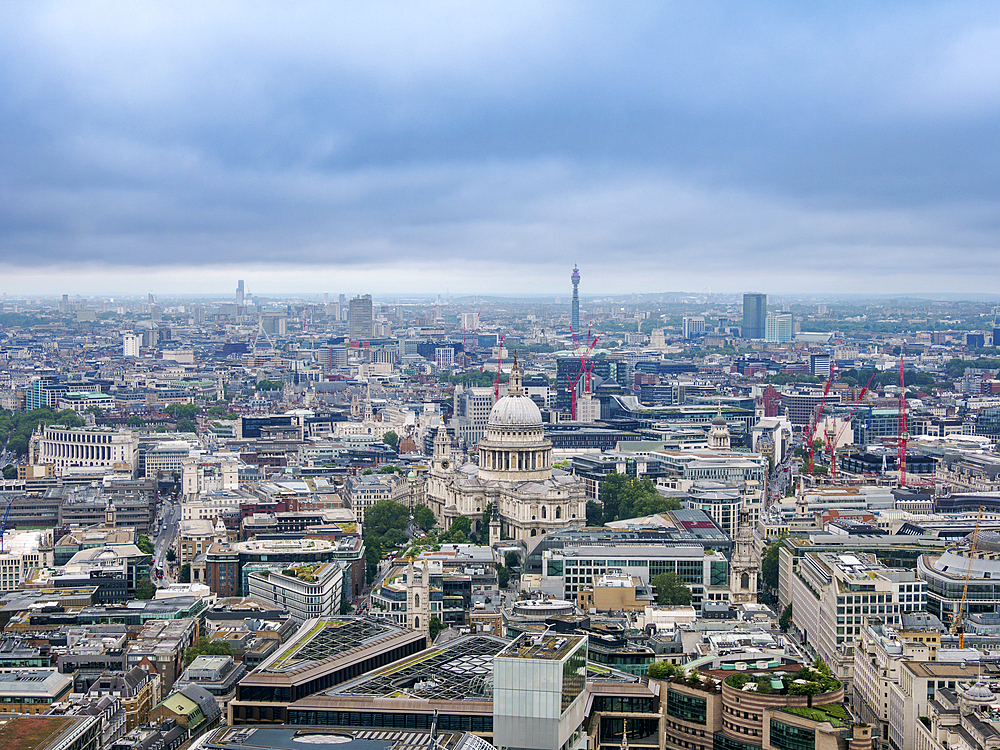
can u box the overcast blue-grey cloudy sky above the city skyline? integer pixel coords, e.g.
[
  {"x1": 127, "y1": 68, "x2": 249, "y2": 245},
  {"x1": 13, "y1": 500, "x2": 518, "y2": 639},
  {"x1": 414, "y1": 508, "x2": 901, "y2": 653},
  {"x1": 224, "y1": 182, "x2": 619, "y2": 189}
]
[{"x1": 0, "y1": 0, "x2": 1000, "y2": 296}]
